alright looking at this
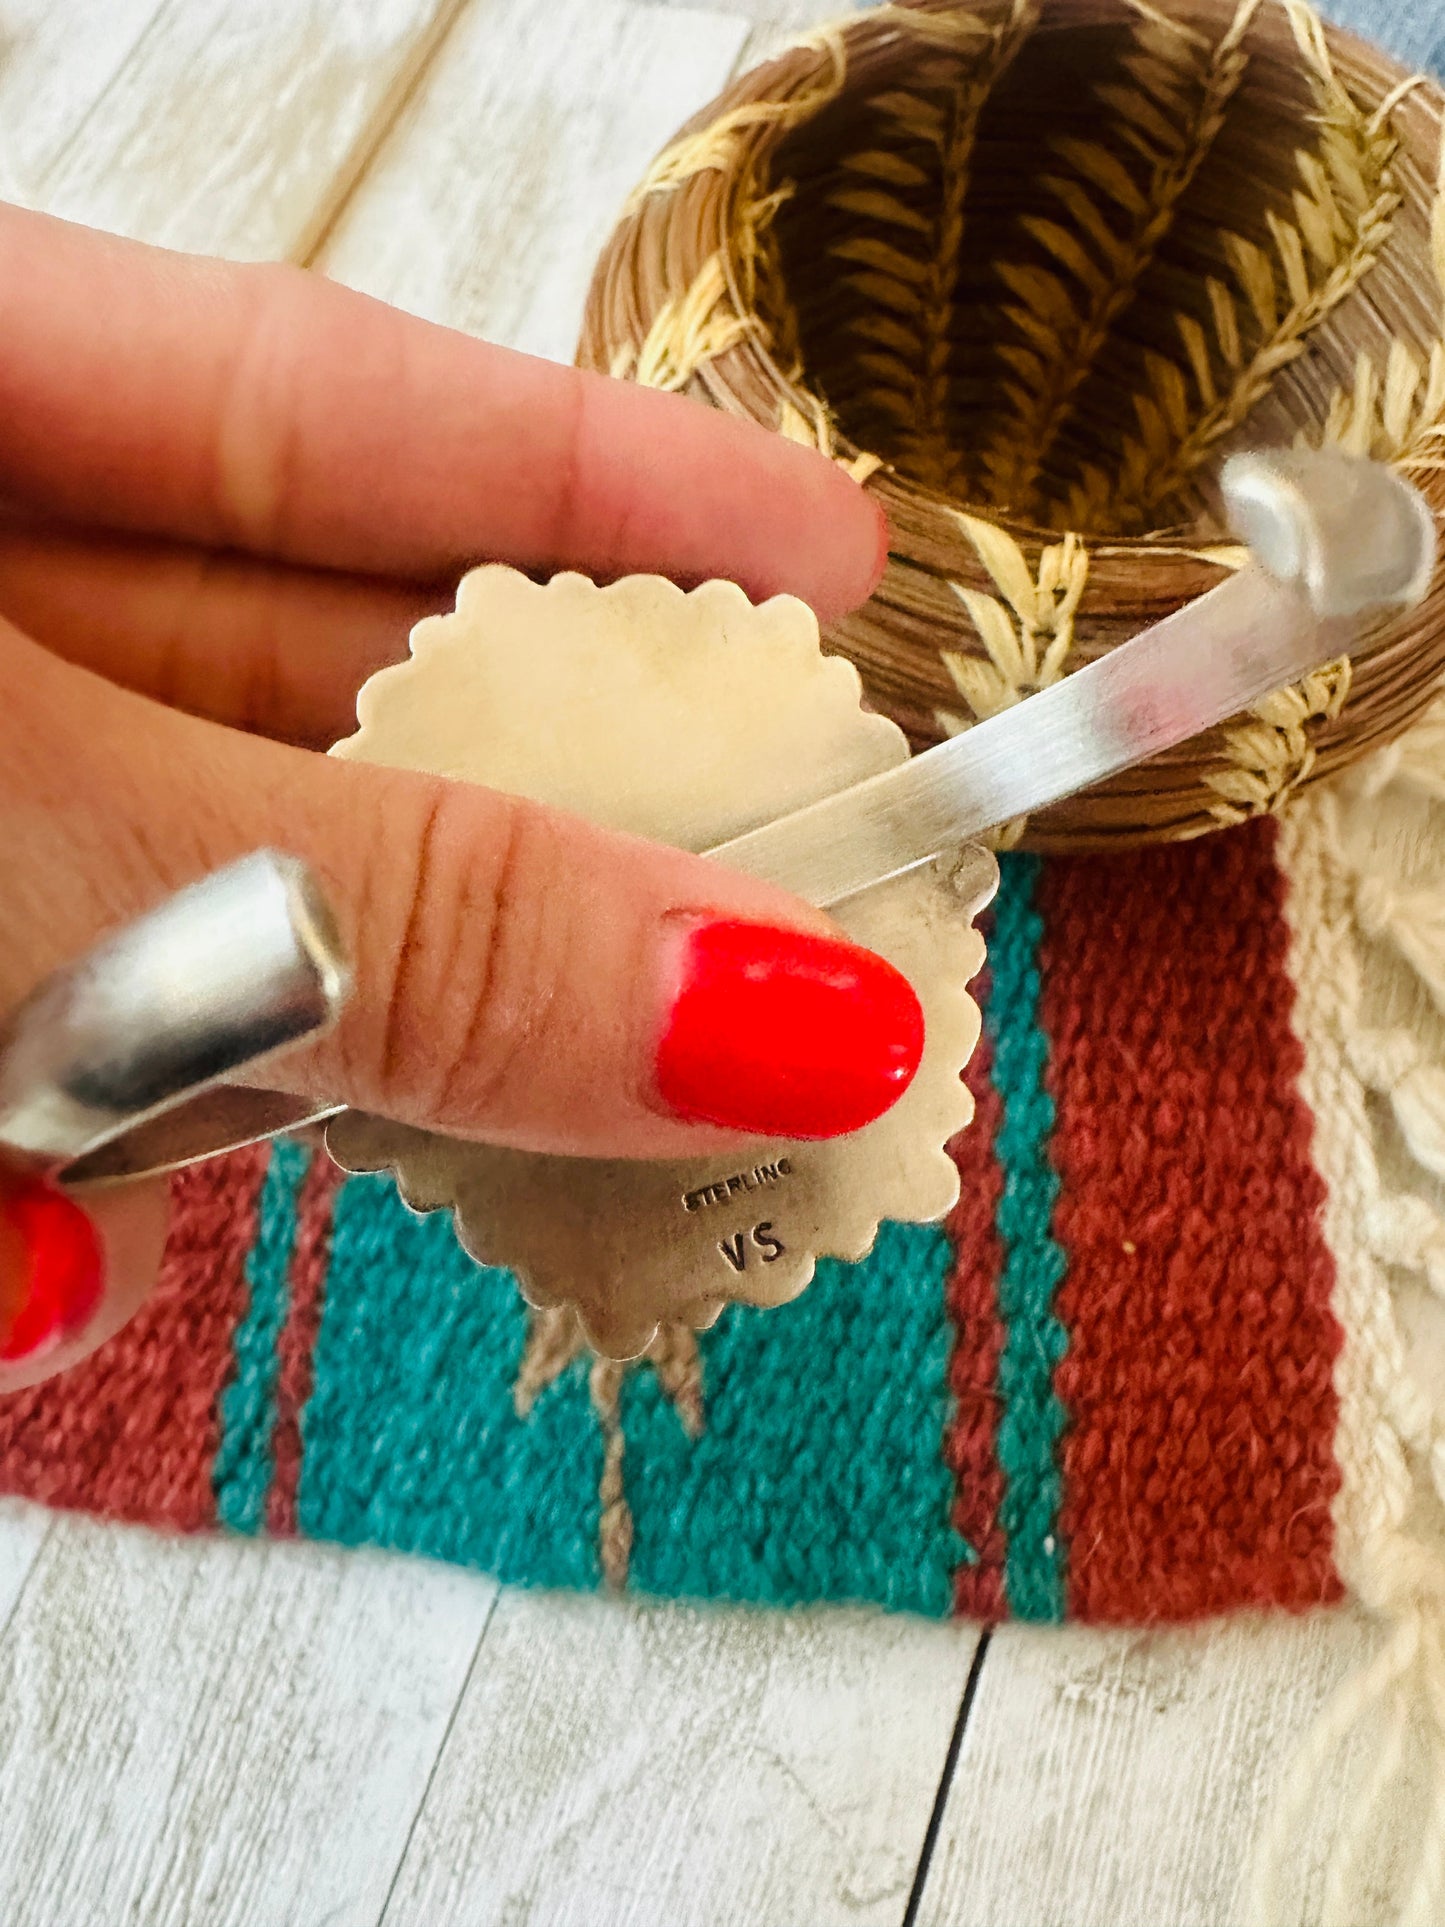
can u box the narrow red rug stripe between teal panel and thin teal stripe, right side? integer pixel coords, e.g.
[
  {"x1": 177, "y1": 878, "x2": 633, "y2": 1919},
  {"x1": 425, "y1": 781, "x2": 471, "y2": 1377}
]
[{"x1": 944, "y1": 981, "x2": 1006, "y2": 1621}]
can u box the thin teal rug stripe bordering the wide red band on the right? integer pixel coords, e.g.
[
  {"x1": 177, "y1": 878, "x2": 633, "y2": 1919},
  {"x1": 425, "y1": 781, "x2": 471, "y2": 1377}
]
[{"x1": 985, "y1": 856, "x2": 1067, "y2": 1621}]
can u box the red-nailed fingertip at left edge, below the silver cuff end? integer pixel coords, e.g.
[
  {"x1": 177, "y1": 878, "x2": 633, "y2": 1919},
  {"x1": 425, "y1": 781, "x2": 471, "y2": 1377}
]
[{"x1": 0, "y1": 1170, "x2": 170, "y2": 1393}]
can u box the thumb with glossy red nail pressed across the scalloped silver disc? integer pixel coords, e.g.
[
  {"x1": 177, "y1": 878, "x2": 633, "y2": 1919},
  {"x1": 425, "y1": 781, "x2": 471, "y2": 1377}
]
[{"x1": 0, "y1": 632, "x2": 923, "y2": 1156}]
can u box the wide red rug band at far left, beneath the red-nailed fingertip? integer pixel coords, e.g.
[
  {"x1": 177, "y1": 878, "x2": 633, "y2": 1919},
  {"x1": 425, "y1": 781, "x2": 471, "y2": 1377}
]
[{"x1": 0, "y1": 1147, "x2": 266, "y2": 1532}]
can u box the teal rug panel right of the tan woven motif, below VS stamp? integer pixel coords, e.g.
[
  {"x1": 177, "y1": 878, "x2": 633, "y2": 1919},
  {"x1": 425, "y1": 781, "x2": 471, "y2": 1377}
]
[{"x1": 622, "y1": 1224, "x2": 975, "y2": 1619}]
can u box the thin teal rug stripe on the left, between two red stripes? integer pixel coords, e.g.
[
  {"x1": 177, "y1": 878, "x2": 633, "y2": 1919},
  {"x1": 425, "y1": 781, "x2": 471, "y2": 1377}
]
[{"x1": 212, "y1": 1139, "x2": 310, "y2": 1532}]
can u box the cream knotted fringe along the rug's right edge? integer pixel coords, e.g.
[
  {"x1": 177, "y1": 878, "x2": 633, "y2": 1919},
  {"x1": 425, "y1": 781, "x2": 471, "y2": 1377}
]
[{"x1": 1271, "y1": 701, "x2": 1445, "y2": 1927}]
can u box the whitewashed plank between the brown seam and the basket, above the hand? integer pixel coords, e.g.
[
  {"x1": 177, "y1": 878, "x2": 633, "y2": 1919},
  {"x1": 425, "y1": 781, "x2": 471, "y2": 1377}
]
[{"x1": 316, "y1": 0, "x2": 748, "y2": 360}]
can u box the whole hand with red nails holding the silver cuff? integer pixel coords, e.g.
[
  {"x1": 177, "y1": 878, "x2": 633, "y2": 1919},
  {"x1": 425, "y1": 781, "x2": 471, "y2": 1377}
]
[{"x1": 0, "y1": 208, "x2": 921, "y2": 1389}]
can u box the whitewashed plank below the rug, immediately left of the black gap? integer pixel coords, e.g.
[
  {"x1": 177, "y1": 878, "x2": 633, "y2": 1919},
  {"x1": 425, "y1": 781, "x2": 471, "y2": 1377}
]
[{"x1": 385, "y1": 1594, "x2": 975, "y2": 1927}]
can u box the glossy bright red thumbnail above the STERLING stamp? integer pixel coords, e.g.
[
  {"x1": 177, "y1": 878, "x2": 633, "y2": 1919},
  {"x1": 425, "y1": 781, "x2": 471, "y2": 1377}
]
[{"x1": 657, "y1": 923, "x2": 923, "y2": 1137}]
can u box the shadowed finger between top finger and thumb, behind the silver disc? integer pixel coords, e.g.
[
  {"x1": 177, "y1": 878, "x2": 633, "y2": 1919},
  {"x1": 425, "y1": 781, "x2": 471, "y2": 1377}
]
[{"x1": 0, "y1": 526, "x2": 453, "y2": 748}]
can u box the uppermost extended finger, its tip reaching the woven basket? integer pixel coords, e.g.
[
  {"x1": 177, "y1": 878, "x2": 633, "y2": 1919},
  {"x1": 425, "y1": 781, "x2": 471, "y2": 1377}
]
[{"x1": 0, "y1": 208, "x2": 886, "y2": 619}]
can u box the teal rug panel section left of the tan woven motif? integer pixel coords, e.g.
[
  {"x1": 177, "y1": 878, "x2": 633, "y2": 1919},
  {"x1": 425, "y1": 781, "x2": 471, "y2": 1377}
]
[{"x1": 297, "y1": 1177, "x2": 603, "y2": 1588}]
